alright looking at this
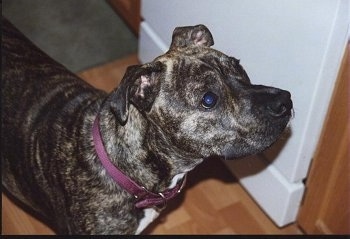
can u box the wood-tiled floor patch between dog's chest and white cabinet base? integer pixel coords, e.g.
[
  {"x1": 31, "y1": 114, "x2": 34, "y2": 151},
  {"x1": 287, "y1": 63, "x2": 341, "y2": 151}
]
[{"x1": 145, "y1": 159, "x2": 301, "y2": 234}]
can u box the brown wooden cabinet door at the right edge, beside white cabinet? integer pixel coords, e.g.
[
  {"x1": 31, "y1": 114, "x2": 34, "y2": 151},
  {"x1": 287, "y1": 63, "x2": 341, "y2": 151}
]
[{"x1": 298, "y1": 44, "x2": 350, "y2": 234}]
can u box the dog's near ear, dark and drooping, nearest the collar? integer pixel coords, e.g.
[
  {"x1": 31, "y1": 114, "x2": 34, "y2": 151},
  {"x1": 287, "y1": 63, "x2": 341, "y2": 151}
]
[{"x1": 107, "y1": 61, "x2": 164, "y2": 125}]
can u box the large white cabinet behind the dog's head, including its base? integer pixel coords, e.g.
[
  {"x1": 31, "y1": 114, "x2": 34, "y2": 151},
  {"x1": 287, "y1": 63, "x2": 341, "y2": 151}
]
[{"x1": 139, "y1": 0, "x2": 350, "y2": 226}]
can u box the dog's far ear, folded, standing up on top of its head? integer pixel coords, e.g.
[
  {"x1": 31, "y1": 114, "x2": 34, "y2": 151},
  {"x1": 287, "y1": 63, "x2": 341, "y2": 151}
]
[{"x1": 170, "y1": 25, "x2": 214, "y2": 49}]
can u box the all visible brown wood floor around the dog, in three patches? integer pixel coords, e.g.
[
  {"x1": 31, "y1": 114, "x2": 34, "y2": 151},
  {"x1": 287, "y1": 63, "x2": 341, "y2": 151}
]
[{"x1": 2, "y1": 55, "x2": 301, "y2": 235}]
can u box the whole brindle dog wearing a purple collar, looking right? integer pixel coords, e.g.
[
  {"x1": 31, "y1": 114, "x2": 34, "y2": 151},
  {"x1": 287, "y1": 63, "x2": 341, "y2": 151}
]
[{"x1": 1, "y1": 19, "x2": 293, "y2": 234}]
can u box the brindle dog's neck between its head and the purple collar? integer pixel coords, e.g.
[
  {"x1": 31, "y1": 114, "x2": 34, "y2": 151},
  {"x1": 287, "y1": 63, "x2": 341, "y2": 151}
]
[{"x1": 95, "y1": 106, "x2": 201, "y2": 192}]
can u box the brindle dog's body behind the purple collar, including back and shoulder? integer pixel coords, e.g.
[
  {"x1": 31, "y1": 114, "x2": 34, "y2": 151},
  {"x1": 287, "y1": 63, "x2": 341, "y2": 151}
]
[{"x1": 1, "y1": 19, "x2": 154, "y2": 234}]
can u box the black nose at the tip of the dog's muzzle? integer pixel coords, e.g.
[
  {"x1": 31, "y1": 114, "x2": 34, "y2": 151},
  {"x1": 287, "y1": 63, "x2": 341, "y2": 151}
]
[{"x1": 266, "y1": 90, "x2": 293, "y2": 117}]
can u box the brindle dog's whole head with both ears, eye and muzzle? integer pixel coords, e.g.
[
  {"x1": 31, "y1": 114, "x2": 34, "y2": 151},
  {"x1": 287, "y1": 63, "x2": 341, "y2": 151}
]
[{"x1": 107, "y1": 25, "x2": 292, "y2": 162}]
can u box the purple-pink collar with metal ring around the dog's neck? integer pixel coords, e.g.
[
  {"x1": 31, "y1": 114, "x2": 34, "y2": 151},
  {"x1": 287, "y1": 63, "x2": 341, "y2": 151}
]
[{"x1": 92, "y1": 117, "x2": 186, "y2": 208}]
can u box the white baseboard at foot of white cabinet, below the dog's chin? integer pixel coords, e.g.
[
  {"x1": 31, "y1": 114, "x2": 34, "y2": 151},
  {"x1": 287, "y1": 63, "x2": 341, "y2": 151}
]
[{"x1": 225, "y1": 156, "x2": 305, "y2": 227}]
